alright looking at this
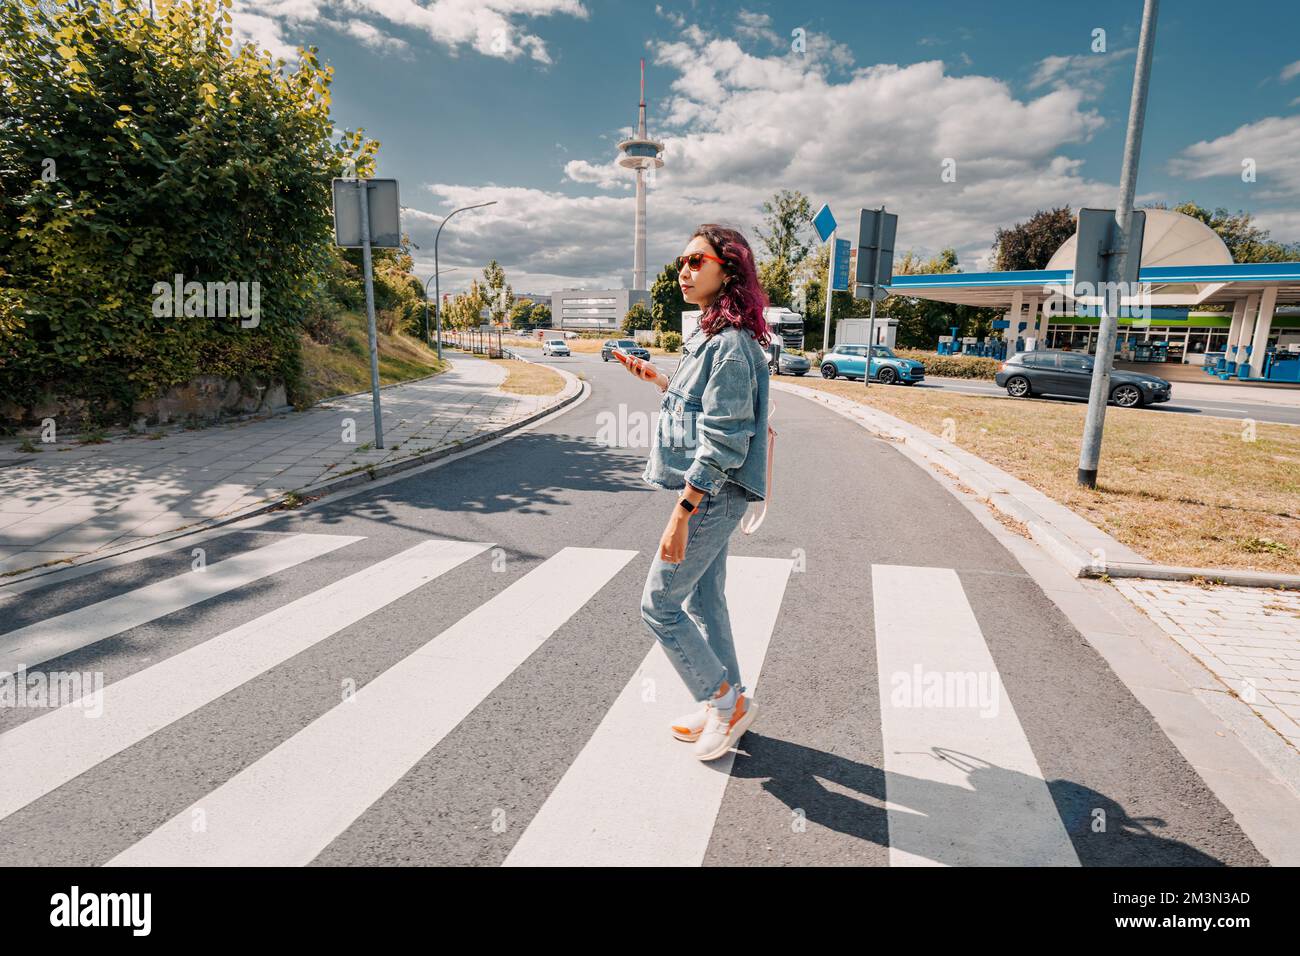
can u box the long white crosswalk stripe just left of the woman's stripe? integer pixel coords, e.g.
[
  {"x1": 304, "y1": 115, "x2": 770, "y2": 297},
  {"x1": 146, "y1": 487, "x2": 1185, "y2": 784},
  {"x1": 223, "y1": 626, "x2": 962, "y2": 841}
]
[{"x1": 108, "y1": 548, "x2": 636, "y2": 866}]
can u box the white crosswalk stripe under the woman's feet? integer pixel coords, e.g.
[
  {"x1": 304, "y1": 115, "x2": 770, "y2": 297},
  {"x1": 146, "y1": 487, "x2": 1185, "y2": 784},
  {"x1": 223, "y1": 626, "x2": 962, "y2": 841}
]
[{"x1": 504, "y1": 558, "x2": 794, "y2": 866}]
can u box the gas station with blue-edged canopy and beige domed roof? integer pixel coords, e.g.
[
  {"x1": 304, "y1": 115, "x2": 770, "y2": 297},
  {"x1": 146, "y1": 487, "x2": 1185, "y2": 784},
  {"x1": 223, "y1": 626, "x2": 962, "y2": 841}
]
[{"x1": 889, "y1": 209, "x2": 1300, "y2": 385}]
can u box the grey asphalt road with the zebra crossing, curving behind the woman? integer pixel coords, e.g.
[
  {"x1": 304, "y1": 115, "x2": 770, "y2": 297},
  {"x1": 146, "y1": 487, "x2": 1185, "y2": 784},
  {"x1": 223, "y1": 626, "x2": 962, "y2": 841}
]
[{"x1": 0, "y1": 356, "x2": 1264, "y2": 866}]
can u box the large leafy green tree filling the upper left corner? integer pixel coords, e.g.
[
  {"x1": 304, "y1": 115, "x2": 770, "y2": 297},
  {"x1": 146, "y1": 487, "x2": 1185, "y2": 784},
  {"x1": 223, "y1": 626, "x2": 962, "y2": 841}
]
[{"x1": 0, "y1": 0, "x2": 378, "y2": 420}]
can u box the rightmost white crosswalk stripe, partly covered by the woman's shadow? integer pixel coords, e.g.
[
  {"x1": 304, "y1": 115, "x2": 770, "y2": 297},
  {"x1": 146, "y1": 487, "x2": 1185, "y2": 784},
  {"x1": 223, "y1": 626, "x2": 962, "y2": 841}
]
[{"x1": 871, "y1": 564, "x2": 1079, "y2": 866}]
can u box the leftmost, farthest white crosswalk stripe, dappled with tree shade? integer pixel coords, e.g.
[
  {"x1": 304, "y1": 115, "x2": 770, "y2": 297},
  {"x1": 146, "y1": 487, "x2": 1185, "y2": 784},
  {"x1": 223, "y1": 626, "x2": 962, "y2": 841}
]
[{"x1": 0, "y1": 535, "x2": 361, "y2": 674}]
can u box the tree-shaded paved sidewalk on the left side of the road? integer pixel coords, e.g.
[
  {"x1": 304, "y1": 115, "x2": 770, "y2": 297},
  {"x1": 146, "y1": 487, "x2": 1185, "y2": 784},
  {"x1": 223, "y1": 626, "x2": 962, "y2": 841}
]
[{"x1": 0, "y1": 352, "x2": 562, "y2": 574}]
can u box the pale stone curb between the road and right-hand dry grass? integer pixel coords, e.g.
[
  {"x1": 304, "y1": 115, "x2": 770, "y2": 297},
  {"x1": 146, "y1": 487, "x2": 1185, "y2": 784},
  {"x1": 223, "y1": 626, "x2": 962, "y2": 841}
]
[{"x1": 772, "y1": 378, "x2": 1300, "y2": 589}]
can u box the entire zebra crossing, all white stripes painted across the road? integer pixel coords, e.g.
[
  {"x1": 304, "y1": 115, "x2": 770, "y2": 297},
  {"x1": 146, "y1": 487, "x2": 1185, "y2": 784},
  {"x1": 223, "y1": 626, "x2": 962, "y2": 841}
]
[{"x1": 0, "y1": 533, "x2": 1097, "y2": 866}]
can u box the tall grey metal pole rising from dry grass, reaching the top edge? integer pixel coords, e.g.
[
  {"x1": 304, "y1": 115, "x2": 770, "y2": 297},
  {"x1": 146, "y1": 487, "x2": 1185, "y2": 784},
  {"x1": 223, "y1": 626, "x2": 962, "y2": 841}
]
[{"x1": 1078, "y1": 0, "x2": 1160, "y2": 488}]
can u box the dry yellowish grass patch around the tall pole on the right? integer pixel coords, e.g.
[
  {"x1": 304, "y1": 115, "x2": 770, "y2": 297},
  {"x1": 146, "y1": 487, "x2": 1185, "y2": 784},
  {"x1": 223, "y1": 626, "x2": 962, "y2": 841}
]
[{"x1": 800, "y1": 378, "x2": 1300, "y2": 574}]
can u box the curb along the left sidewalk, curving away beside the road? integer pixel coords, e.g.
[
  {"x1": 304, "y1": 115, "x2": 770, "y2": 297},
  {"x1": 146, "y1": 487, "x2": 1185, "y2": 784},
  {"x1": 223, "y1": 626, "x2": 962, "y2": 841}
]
[{"x1": 0, "y1": 359, "x2": 582, "y2": 591}]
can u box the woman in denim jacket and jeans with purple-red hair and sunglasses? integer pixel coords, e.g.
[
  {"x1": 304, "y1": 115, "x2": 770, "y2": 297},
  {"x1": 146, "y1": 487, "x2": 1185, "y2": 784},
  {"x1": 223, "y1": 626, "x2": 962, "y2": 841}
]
[{"x1": 631, "y1": 224, "x2": 768, "y2": 760}]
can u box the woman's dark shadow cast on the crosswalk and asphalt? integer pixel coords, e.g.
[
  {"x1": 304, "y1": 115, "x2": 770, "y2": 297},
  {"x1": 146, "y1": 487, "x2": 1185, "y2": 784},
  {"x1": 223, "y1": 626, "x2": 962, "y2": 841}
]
[{"x1": 732, "y1": 731, "x2": 1223, "y2": 866}]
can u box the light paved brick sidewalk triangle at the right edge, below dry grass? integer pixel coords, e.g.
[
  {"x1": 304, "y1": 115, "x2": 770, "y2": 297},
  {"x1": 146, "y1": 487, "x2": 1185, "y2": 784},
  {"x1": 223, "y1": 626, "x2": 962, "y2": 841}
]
[{"x1": 1112, "y1": 579, "x2": 1300, "y2": 750}]
